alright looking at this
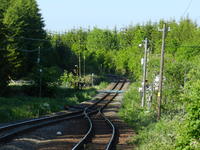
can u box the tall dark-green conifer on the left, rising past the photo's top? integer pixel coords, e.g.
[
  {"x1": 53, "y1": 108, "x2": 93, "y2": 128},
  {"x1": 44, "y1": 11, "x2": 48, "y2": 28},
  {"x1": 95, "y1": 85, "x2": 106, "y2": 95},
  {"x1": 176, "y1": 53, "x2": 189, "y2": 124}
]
[{"x1": 3, "y1": 0, "x2": 46, "y2": 77}]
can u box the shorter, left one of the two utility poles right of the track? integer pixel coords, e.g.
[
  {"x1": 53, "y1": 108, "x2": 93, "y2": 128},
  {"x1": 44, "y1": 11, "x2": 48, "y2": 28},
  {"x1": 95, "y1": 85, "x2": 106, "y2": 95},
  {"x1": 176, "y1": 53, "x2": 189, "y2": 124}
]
[{"x1": 141, "y1": 38, "x2": 148, "y2": 107}]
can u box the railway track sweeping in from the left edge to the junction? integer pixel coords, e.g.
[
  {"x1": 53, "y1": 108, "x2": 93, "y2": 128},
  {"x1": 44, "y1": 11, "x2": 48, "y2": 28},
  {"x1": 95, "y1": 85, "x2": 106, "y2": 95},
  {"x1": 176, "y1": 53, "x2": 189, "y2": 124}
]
[{"x1": 0, "y1": 79, "x2": 125, "y2": 149}]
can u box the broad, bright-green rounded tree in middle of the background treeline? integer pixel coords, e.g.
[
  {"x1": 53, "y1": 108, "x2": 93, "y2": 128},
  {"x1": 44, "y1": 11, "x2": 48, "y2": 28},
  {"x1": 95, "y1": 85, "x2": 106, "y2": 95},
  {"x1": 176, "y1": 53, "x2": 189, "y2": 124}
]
[{"x1": 87, "y1": 28, "x2": 118, "y2": 72}]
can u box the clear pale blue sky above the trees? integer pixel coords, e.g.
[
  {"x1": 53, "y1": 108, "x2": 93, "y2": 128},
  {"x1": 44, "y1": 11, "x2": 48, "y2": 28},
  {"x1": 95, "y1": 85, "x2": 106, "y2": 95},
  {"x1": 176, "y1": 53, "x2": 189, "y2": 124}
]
[{"x1": 37, "y1": 0, "x2": 200, "y2": 31}]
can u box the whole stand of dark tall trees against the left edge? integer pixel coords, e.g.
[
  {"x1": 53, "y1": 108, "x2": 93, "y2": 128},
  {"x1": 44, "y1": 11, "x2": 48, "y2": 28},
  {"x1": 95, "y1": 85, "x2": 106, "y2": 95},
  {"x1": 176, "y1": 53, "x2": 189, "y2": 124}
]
[{"x1": 0, "y1": 0, "x2": 46, "y2": 93}]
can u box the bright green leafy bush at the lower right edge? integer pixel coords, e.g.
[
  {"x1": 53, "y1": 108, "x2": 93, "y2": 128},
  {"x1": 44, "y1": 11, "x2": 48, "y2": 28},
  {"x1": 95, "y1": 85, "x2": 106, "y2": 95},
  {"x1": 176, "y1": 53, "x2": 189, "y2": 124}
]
[{"x1": 177, "y1": 80, "x2": 200, "y2": 150}]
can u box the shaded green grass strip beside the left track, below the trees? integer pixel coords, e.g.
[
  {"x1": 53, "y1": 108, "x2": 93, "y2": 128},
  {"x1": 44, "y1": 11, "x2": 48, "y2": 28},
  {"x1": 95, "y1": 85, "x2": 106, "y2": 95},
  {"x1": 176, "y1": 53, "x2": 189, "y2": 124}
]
[{"x1": 0, "y1": 87, "x2": 96, "y2": 123}]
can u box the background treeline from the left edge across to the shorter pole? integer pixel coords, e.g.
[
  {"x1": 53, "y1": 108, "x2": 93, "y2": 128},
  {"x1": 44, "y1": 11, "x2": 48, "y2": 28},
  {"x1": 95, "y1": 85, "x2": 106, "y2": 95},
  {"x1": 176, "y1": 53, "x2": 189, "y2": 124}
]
[{"x1": 0, "y1": 0, "x2": 145, "y2": 94}]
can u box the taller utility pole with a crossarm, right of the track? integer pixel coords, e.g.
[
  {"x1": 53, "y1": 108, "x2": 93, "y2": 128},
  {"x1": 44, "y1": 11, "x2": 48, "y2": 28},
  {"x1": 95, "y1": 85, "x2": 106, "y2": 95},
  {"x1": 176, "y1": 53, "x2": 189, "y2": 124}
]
[{"x1": 157, "y1": 23, "x2": 170, "y2": 120}]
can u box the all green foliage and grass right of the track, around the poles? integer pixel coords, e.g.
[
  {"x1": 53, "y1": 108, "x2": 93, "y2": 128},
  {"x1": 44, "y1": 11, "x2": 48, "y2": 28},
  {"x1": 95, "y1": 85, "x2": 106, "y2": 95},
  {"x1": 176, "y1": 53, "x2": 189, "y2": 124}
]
[{"x1": 121, "y1": 18, "x2": 200, "y2": 150}]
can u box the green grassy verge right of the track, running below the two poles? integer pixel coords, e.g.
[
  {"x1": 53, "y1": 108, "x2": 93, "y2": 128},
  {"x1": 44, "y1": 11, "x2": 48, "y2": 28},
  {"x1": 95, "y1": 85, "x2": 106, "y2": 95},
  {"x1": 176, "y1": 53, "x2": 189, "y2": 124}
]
[{"x1": 119, "y1": 83, "x2": 181, "y2": 150}]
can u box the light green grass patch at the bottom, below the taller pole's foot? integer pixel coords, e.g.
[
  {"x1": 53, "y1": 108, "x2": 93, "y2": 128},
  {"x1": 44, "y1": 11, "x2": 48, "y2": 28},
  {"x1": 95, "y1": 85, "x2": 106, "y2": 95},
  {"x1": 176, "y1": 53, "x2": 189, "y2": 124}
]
[{"x1": 133, "y1": 118, "x2": 179, "y2": 150}]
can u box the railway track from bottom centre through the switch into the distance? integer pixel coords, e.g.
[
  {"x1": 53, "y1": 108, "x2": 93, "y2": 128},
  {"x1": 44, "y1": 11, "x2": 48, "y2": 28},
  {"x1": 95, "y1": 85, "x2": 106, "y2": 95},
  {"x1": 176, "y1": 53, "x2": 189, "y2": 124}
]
[{"x1": 72, "y1": 81, "x2": 125, "y2": 150}]
